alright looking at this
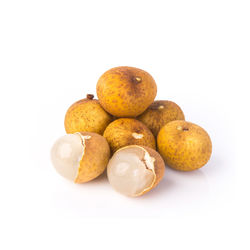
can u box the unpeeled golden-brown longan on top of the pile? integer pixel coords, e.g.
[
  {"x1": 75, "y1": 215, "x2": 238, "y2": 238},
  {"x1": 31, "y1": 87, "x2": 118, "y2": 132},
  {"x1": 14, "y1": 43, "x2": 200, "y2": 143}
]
[{"x1": 96, "y1": 67, "x2": 157, "y2": 117}]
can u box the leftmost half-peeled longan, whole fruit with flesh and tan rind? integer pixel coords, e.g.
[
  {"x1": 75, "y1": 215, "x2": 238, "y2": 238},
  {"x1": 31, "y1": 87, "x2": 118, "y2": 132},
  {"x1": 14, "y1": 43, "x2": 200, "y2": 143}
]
[{"x1": 51, "y1": 132, "x2": 110, "y2": 183}]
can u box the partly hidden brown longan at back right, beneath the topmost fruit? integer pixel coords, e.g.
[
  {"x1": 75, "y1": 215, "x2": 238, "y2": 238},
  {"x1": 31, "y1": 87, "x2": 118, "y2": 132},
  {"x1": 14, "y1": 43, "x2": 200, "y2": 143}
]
[{"x1": 137, "y1": 101, "x2": 185, "y2": 137}]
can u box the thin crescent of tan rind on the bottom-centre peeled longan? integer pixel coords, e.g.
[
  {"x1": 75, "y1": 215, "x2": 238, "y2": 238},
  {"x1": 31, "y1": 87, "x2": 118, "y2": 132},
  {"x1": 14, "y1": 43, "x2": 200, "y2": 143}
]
[{"x1": 140, "y1": 146, "x2": 165, "y2": 195}]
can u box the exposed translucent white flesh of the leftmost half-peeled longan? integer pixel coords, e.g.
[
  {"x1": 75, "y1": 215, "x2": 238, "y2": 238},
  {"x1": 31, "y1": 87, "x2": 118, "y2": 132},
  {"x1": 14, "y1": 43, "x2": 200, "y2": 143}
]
[{"x1": 51, "y1": 134, "x2": 84, "y2": 181}]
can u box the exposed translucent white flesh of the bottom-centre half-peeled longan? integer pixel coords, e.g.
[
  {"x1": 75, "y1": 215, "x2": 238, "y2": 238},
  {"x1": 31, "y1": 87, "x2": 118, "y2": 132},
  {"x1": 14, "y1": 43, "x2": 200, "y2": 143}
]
[{"x1": 107, "y1": 147, "x2": 155, "y2": 196}]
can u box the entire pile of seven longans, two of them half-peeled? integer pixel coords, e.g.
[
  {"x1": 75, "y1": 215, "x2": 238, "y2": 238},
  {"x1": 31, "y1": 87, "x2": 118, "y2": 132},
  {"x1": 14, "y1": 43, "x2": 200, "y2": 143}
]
[{"x1": 51, "y1": 67, "x2": 212, "y2": 196}]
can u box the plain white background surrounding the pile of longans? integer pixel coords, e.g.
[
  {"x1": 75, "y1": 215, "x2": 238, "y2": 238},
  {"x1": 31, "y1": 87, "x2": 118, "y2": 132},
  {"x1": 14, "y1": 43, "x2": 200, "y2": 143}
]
[{"x1": 0, "y1": 0, "x2": 250, "y2": 250}]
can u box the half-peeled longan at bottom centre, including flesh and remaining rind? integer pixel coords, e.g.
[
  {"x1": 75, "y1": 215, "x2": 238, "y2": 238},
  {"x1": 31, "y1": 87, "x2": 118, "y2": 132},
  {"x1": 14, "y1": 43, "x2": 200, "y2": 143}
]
[{"x1": 107, "y1": 145, "x2": 165, "y2": 196}]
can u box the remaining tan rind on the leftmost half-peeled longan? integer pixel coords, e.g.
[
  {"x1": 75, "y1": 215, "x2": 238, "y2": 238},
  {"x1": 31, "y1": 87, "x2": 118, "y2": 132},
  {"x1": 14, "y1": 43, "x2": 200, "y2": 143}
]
[{"x1": 75, "y1": 132, "x2": 110, "y2": 183}]
